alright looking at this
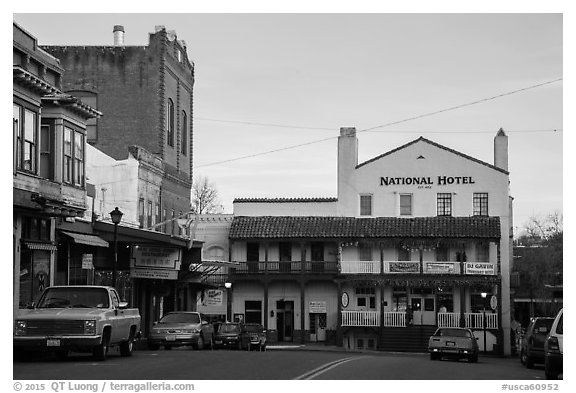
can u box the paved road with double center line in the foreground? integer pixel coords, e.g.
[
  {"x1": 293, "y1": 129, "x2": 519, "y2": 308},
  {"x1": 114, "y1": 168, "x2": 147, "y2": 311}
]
[{"x1": 13, "y1": 348, "x2": 544, "y2": 381}]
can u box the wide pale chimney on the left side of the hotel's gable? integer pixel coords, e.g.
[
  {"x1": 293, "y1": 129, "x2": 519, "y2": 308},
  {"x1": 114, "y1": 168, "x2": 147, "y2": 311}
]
[{"x1": 338, "y1": 127, "x2": 358, "y2": 211}]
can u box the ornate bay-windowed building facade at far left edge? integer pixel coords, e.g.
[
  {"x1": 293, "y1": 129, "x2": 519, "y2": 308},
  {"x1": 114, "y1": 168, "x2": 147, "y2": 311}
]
[{"x1": 12, "y1": 23, "x2": 101, "y2": 312}]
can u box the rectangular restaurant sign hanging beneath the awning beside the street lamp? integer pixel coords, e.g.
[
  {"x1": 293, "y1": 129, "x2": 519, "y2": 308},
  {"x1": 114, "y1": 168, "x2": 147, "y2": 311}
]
[{"x1": 130, "y1": 246, "x2": 182, "y2": 280}]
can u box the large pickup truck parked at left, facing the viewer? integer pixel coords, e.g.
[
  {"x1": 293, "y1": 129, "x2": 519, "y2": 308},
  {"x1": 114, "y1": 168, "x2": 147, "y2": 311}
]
[{"x1": 14, "y1": 286, "x2": 140, "y2": 360}]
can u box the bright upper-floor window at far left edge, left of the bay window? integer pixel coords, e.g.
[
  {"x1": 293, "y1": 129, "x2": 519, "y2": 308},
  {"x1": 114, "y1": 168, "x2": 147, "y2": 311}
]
[{"x1": 13, "y1": 104, "x2": 38, "y2": 173}]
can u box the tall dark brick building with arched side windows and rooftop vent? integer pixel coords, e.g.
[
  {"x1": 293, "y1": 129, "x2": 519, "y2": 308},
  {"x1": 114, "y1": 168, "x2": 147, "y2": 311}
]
[{"x1": 43, "y1": 26, "x2": 194, "y2": 233}]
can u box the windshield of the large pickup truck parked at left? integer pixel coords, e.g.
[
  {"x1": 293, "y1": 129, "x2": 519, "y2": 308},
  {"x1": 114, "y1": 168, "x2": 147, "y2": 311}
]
[{"x1": 38, "y1": 287, "x2": 109, "y2": 308}]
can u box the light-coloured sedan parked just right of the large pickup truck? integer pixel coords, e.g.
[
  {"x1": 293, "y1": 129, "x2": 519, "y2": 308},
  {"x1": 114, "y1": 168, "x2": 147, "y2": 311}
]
[{"x1": 148, "y1": 311, "x2": 214, "y2": 350}]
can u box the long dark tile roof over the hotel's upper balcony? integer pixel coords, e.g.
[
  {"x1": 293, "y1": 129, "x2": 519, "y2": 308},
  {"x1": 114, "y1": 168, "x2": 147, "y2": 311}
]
[{"x1": 229, "y1": 216, "x2": 500, "y2": 240}]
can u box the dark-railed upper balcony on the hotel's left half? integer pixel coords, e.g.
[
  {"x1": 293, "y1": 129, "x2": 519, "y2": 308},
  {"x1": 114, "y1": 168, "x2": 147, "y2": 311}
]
[{"x1": 231, "y1": 261, "x2": 338, "y2": 274}]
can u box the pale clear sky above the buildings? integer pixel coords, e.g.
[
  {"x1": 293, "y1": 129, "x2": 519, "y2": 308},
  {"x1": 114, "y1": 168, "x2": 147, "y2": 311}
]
[{"x1": 13, "y1": 13, "x2": 564, "y2": 231}]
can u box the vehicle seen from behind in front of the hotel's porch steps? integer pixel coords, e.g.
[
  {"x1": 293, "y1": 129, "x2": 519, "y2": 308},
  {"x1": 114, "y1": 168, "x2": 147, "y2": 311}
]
[{"x1": 428, "y1": 328, "x2": 478, "y2": 363}]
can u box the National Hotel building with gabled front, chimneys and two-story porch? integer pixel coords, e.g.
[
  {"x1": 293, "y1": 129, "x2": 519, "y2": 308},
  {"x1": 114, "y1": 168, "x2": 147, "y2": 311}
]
[{"x1": 227, "y1": 128, "x2": 512, "y2": 355}]
